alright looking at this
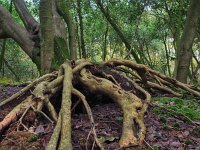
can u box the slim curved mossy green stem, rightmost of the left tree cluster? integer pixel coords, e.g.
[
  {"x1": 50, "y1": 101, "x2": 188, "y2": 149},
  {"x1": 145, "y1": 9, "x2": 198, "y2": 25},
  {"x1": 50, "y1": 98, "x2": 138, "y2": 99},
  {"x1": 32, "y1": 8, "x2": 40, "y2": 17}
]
[{"x1": 56, "y1": 0, "x2": 77, "y2": 59}]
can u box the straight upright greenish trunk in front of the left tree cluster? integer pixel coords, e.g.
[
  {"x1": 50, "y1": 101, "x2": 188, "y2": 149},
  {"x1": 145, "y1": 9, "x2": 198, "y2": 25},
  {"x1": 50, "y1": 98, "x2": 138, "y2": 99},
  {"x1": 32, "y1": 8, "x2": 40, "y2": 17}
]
[{"x1": 40, "y1": 0, "x2": 54, "y2": 74}]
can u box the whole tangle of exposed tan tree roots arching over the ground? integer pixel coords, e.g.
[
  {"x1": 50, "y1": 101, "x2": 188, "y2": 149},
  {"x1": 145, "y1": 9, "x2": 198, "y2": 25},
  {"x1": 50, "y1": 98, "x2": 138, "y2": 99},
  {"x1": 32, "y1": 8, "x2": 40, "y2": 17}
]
[{"x1": 0, "y1": 59, "x2": 200, "y2": 150}]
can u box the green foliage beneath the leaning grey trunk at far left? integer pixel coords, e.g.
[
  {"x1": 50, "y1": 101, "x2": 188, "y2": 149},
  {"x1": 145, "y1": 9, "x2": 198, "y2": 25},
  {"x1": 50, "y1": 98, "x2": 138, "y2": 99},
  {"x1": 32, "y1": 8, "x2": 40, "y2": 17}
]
[{"x1": 0, "y1": 39, "x2": 38, "y2": 81}]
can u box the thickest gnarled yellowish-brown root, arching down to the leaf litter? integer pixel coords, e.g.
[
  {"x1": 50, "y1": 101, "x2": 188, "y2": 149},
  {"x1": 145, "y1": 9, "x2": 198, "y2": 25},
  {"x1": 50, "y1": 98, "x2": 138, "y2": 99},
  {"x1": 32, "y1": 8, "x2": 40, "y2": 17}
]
[{"x1": 80, "y1": 69, "x2": 143, "y2": 147}]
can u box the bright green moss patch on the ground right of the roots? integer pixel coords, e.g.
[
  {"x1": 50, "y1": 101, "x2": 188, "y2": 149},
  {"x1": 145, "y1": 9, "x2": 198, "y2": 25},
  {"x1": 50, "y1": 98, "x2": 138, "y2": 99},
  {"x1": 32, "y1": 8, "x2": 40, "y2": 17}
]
[{"x1": 153, "y1": 97, "x2": 200, "y2": 120}]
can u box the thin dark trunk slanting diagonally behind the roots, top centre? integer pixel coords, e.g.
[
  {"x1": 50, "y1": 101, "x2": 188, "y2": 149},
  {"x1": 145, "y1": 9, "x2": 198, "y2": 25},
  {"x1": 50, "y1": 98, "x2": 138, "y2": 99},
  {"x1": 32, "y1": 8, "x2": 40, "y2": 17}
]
[{"x1": 95, "y1": 0, "x2": 140, "y2": 63}]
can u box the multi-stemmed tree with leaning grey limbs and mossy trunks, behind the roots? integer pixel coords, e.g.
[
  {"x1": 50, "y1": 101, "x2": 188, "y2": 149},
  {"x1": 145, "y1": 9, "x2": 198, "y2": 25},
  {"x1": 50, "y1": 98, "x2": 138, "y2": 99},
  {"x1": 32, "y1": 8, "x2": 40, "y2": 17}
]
[{"x1": 0, "y1": 0, "x2": 77, "y2": 73}]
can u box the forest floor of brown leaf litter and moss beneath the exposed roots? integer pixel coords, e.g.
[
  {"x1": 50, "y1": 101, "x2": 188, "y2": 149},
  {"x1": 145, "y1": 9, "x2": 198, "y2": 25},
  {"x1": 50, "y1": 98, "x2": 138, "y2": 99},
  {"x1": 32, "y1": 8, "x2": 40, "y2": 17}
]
[{"x1": 0, "y1": 85, "x2": 200, "y2": 150}]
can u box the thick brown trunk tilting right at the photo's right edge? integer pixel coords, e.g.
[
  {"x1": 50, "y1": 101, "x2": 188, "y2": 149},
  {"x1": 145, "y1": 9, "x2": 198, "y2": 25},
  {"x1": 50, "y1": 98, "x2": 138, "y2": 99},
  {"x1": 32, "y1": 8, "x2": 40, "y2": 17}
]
[{"x1": 176, "y1": 0, "x2": 200, "y2": 83}]
